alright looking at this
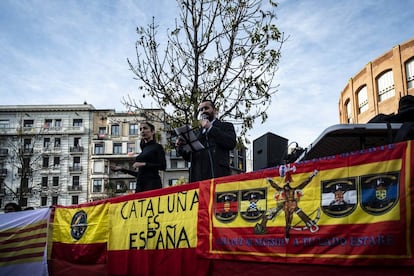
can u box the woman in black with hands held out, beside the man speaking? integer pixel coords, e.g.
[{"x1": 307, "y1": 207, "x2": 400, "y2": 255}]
[{"x1": 111, "y1": 122, "x2": 166, "y2": 192}]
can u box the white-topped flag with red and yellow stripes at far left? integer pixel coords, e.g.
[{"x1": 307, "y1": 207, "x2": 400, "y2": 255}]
[{"x1": 0, "y1": 209, "x2": 50, "y2": 275}]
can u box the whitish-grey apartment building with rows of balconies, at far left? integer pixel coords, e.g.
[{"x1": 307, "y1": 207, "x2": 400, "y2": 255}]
[{"x1": 0, "y1": 104, "x2": 94, "y2": 207}]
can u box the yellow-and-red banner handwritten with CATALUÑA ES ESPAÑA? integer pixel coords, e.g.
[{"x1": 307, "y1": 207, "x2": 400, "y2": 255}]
[{"x1": 108, "y1": 184, "x2": 208, "y2": 275}]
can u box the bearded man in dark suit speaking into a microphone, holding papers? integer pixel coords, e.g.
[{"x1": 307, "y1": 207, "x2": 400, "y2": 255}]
[{"x1": 176, "y1": 100, "x2": 236, "y2": 182}]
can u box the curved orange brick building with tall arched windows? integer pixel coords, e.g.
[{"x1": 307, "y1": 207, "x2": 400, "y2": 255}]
[{"x1": 339, "y1": 39, "x2": 414, "y2": 124}]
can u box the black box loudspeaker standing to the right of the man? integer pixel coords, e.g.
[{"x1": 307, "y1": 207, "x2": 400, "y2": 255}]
[{"x1": 253, "y1": 132, "x2": 288, "y2": 171}]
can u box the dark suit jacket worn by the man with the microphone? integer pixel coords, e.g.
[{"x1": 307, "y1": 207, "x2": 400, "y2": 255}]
[{"x1": 178, "y1": 119, "x2": 236, "y2": 182}]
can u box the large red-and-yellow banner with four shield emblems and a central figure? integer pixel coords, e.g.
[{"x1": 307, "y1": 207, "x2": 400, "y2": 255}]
[{"x1": 197, "y1": 143, "x2": 414, "y2": 266}]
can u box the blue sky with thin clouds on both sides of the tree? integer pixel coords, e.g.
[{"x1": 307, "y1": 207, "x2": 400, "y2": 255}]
[{"x1": 0, "y1": 0, "x2": 414, "y2": 147}]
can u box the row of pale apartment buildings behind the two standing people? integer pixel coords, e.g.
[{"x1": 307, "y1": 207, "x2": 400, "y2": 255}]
[{"x1": 0, "y1": 103, "x2": 246, "y2": 209}]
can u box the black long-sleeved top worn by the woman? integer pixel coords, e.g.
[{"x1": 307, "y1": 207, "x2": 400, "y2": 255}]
[{"x1": 121, "y1": 141, "x2": 167, "y2": 192}]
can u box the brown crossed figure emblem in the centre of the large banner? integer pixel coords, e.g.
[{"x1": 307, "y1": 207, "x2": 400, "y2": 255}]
[{"x1": 254, "y1": 166, "x2": 320, "y2": 242}]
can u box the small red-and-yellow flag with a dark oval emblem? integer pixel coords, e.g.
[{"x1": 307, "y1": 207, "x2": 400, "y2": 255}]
[{"x1": 49, "y1": 201, "x2": 109, "y2": 275}]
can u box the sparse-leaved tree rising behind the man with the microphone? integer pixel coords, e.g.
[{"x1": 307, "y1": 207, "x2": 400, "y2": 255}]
[{"x1": 123, "y1": 0, "x2": 285, "y2": 140}]
